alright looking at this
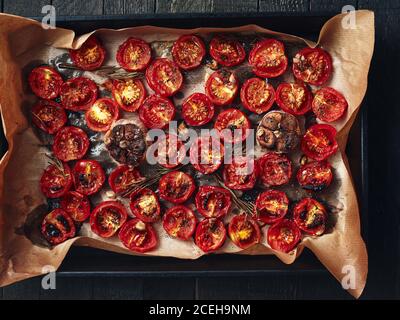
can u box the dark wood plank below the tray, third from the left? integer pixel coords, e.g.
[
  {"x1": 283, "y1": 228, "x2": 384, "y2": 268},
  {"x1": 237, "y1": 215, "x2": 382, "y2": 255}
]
[{"x1": 93, "y1": 276, "x2": 143, "y2": 300}]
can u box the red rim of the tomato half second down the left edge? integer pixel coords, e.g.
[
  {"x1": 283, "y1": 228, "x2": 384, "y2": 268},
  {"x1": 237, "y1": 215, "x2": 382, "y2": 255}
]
[{"x1": 32, "y1": 100, "x2": 67, "y2": 134}]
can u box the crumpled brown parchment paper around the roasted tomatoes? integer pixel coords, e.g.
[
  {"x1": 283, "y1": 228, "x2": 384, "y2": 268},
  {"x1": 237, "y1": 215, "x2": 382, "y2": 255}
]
[{"x1": 0, "y1": 10, "x2": 374, "y2": 297}]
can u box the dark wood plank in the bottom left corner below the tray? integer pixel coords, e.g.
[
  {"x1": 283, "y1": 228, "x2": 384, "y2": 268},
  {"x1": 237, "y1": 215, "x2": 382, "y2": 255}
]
[{"x1": 3, "y1": 277, "x2": 42, "y2": 300}]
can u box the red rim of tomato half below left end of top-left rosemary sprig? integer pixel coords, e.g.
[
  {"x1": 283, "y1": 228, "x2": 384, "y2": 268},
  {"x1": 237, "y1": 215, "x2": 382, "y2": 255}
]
[{"x1": 60, "y1": 77, "x2": 99, "y2": 111}]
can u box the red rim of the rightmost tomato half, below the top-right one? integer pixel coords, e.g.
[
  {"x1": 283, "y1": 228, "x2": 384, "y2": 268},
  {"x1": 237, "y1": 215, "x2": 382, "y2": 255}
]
[{"x1": 312, "y1": 87, "x2": 348, "y2": 122}]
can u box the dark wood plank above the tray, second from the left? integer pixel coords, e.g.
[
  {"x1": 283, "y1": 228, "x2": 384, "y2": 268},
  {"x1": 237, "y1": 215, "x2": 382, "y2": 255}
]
[{"x1": 53, "y1": 0, "x2": 103, "y2": 16}]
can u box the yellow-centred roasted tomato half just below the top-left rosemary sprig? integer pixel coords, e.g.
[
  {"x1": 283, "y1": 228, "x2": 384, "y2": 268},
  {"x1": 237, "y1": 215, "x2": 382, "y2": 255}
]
[{"x1": 112, "y1": 79, "x2": 146, "y2": 112}]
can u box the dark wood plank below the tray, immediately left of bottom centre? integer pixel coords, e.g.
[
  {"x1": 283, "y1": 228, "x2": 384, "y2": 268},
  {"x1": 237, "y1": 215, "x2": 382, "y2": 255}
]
[{"x1": 143, "y1": 278, "x2": 195, "y2": 300}]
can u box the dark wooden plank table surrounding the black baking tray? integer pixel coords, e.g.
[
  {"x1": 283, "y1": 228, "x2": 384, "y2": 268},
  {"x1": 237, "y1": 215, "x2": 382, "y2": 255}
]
[{"x1": 0, "y1": 0, "x2": 400, "y2": 299}]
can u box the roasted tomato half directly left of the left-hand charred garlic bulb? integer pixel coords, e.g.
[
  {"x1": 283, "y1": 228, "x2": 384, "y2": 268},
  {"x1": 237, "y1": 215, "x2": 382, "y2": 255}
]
[{"x1": 53, "y1": 127, "x2": 89, "y2": 161}]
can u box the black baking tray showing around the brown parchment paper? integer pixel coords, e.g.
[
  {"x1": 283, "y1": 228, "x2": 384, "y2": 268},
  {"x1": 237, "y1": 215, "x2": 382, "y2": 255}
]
[{"x1": 0, "y1": 13, "x2": 368, "y2": 277}]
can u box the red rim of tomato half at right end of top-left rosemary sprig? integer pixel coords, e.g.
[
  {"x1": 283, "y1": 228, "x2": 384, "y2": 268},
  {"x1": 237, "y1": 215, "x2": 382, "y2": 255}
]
[{"x1": 146, "y1": 58, "x2": 183, "y2": 98}]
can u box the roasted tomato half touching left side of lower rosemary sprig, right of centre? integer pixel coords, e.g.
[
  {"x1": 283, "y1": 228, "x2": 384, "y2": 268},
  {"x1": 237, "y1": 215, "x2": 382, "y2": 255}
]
[{"x1": 195, "y1": 186, "x2": 232, "y2": 218}]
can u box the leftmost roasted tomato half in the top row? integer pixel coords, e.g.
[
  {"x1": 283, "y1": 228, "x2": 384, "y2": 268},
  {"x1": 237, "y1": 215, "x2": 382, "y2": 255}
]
[{"x1": 69, "y1": 36, "x2": 106, "y2": 70}]
